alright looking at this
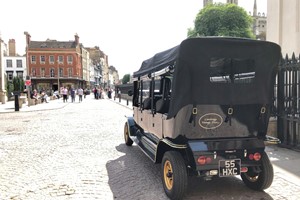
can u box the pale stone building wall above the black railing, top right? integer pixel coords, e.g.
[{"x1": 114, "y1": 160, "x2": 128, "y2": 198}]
[{"x1": 267, "y1": 0, "x2": 300, "y2": 57}]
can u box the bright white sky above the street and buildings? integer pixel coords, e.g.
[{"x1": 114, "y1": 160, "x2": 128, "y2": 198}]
[{"x1": 0, "y1": 0, "x2": 267, "y2": 78}]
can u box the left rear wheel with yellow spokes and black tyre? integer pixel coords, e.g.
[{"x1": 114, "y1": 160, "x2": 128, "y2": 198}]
[{"x1": 161, "y1": 151, "x2": 188, "y2": 199}]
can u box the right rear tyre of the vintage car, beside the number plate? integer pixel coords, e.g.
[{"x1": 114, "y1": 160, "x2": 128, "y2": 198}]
[{"x1": 241, "y1": 152, "x2": 274, "y2": 190}]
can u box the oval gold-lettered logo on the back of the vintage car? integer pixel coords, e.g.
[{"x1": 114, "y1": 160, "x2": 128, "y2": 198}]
[{"x1": 199, "y1": 113, "x2": 223, "y2": 129}]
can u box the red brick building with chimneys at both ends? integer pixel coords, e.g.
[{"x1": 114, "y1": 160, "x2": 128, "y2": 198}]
[{"x1": 25, "y1": 32, "x2": 85, "y2": 91}]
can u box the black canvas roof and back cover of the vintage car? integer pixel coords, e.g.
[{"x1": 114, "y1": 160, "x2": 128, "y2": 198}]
[{"x1": 134, "y1": 37, "x2": 281, "y2": 118}]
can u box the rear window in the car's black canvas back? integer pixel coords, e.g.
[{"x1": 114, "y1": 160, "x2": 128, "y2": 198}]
[{"x1": 210, "y1": 58, "x2": 255, "y2": 84}]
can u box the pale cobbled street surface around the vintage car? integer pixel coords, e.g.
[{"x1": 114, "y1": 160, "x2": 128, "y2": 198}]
[{"x1": 0, "y1": 96, "x2": 300, "y2": 200}]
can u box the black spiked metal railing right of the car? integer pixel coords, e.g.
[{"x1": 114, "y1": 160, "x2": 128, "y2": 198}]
[{"x1": 274, "y1": 54, "x2": 300, "y2": 149}]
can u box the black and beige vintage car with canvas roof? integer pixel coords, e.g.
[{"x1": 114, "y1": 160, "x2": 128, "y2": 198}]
[{"x1": 124, "y1": 37, "x2": 281, "y2": 199}]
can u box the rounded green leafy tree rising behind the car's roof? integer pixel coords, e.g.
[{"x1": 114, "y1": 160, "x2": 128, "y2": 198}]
[{"x1": 188, "y1": 3, "x2": 255, "y2": 39}]
